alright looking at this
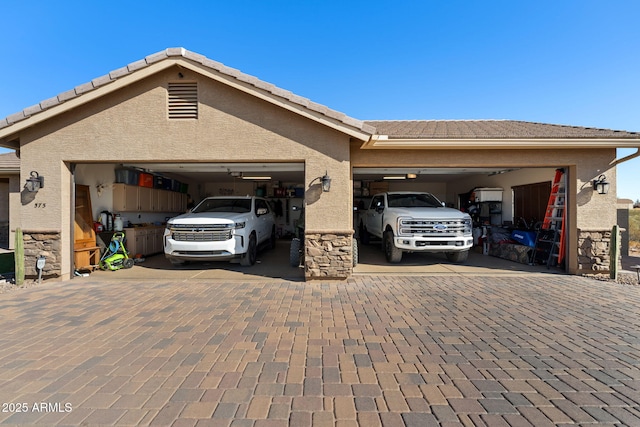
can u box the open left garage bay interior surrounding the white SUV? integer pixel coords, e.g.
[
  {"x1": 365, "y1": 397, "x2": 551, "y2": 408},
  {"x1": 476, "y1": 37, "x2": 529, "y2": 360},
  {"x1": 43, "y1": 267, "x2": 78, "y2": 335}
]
[{"x1": 72, "y1": 162, "x2": 304, "y2": 280}]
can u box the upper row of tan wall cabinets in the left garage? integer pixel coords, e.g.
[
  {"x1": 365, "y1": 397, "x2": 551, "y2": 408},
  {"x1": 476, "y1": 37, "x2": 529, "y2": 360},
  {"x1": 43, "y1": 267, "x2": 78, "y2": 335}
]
[{"x1": 113, "y1": 183, "x2": 187, "y2": 212}]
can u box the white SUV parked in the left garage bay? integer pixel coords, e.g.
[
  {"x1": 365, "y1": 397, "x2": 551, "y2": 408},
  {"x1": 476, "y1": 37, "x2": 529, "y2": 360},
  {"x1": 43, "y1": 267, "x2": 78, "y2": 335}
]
[{"x1": 164, "y1": 196, "x2": 276, "y2": 266}]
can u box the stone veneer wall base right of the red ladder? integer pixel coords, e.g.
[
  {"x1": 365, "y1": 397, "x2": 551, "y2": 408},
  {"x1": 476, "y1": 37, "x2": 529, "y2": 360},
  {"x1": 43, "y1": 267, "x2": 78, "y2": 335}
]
[{"x1": 578, "y1": 228, "x2": 621, "y2": 274}]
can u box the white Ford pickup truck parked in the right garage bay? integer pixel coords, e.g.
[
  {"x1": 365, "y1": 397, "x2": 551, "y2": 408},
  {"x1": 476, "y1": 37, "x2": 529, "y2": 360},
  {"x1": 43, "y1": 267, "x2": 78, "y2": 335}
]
[{"x1": 360, "y1": 192, "x2": 473, "y2": 263}]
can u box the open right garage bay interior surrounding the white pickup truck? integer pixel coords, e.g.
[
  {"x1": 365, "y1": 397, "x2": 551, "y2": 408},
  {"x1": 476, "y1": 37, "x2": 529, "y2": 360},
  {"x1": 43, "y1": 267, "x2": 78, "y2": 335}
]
[{"x1": 353, "y1": 167, "x2": 568, "y2": 274}]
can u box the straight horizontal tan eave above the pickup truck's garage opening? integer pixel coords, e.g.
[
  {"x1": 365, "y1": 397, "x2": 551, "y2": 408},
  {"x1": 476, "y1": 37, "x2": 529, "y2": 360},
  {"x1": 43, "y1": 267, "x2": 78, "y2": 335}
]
[{"x1": 360, "y1": 135, "x2": 640, "y2": 150}]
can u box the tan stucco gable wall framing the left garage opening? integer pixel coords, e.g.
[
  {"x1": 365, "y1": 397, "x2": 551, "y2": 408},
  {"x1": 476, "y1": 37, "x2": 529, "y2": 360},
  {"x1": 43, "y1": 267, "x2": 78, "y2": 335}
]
[{"x1": 16, "y1": 68, "x2": 351, "y2": 276}]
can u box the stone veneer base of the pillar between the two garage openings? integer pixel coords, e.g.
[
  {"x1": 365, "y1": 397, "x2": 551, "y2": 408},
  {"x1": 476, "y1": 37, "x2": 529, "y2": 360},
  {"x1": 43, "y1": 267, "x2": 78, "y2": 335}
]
[{"x1": 304, "y1": 230, "x2": 353, "y2": 279}]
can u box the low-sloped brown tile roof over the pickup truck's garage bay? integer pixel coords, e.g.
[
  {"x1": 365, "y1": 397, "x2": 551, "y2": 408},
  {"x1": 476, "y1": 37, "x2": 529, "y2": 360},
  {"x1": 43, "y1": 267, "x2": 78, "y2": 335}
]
[{"x1": 365, "y1": 120, "x2": 640, "y2": 140}]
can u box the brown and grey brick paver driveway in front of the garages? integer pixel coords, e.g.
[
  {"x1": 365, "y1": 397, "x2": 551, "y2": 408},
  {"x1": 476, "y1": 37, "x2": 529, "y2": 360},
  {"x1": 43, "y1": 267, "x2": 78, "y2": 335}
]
[{"x1": 0, "y1": 274, "x2": 640, "y2": 427}]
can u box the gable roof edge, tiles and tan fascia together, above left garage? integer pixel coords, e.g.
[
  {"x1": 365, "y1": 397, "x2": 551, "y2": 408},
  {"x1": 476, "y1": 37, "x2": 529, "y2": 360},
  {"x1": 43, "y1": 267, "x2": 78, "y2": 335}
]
[{"x1": 0, "y1": 48, "x2": 375, "y2": 143}]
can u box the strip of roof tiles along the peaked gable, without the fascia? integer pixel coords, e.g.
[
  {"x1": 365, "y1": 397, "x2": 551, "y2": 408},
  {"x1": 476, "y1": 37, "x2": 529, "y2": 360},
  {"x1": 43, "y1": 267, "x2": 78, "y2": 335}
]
[{"x1": 0, "y1": 47, "x2": 374, "y2": 134}]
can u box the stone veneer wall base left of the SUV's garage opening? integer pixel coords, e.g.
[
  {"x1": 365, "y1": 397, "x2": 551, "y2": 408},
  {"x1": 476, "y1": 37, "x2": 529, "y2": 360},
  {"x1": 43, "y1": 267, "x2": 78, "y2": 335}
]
[{"x1": 22, "y1": 230, "x2": 62, "y2": 277}]
